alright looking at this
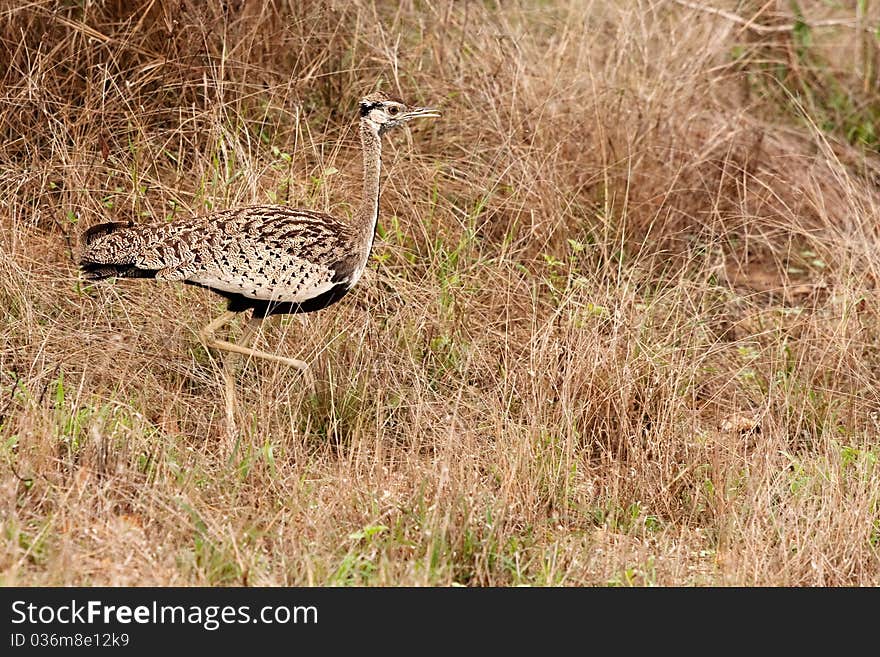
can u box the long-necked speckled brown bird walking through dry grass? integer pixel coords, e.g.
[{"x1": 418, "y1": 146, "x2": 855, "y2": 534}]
[{"x1": 79, "y1": 91, "x2": 440, "y2": 426}]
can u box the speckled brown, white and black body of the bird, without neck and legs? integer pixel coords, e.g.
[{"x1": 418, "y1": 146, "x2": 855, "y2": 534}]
[{"x1": 83, "y1": 205, "x2": 360, "y2": 317}]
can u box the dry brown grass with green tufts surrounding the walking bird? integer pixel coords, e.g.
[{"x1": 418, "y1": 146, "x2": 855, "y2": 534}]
[{"x1": 0, "y1": 0, "x2": 880, "y2": 585}]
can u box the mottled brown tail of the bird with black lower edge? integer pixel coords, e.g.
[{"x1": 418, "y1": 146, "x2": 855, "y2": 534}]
[{"x1": 79, "y1": 222, "x2": 156, "y2": 280}]
